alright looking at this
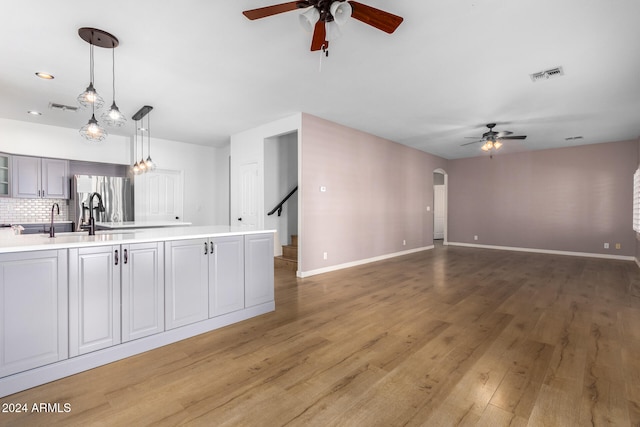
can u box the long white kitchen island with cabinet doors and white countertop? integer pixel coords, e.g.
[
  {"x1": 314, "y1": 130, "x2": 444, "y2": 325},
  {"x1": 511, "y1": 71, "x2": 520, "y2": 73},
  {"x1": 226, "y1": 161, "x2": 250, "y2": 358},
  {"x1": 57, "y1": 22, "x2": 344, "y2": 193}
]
[{"x1": 0, "y1": 226, "x2": 275, "y2": 396}]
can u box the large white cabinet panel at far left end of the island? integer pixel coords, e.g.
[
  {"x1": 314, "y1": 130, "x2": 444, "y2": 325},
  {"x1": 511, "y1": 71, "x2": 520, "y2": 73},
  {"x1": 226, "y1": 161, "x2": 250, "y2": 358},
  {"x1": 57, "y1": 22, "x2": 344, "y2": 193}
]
[{"x1": 0, "y1": 250, "x2": 68, "y2": 377}]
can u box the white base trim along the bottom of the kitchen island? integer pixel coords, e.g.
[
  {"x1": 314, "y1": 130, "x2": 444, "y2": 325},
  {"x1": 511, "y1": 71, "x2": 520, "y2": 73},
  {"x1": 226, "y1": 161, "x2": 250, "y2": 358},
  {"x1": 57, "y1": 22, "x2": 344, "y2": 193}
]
[{"x1": 0, "y1": 301, "x2": 275, "y2": 397}]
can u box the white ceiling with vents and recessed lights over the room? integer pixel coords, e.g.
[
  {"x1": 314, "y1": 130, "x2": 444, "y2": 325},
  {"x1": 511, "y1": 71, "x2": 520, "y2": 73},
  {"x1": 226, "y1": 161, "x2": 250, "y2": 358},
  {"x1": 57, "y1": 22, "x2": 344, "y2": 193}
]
[{"x1": 0, "y1": 0, "x2": 640, "y2": 159}]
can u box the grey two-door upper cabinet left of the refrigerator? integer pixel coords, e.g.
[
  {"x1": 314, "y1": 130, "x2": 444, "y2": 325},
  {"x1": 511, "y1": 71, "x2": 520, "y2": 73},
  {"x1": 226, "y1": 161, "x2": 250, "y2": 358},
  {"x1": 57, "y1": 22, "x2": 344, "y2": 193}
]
[{"x1": 11, "y1": 156, "x2": 69, "y2": 199}]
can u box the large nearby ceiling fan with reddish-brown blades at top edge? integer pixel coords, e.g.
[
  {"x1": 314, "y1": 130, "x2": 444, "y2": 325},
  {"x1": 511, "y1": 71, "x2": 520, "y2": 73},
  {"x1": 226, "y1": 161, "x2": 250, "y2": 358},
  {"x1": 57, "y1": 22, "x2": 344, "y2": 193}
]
[{"x1": 242, "y1": 0, "x2": 403, "y2": 51}]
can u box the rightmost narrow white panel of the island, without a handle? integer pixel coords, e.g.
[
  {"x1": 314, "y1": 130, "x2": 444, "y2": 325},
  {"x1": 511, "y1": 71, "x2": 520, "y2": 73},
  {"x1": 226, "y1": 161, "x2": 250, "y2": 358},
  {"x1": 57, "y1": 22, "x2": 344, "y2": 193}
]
[{"x1": 244, "y1": 233, "x2": 274, "y2": 307}]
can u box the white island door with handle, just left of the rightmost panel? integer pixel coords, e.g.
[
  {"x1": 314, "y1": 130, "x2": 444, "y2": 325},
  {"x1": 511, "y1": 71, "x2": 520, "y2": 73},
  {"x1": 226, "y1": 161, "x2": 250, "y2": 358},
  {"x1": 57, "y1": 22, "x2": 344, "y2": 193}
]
[{"x1": 209, "y1": 236, "x2": 244, "y2": 317}]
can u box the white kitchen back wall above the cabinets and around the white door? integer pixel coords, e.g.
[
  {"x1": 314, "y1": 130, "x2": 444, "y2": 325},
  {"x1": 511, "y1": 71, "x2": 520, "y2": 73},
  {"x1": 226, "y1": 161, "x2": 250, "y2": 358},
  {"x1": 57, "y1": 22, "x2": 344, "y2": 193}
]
[{"x1": 0, "y1": 119, "x2": 228, "y2": 225}]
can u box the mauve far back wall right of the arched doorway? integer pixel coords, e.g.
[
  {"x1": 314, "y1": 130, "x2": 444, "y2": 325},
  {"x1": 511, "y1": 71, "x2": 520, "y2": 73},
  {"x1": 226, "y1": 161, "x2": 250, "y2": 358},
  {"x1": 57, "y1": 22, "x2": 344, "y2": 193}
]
[{"x1": 448, "y1": 141, "x2": 638, "y2": 256}]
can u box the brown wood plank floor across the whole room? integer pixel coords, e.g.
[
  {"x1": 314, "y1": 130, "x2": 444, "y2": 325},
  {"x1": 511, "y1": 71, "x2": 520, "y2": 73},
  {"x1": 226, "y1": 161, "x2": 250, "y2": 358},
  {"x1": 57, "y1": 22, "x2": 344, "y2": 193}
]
[{"x1": 0, "y1": 246, "x2": 640, "y2": 426}]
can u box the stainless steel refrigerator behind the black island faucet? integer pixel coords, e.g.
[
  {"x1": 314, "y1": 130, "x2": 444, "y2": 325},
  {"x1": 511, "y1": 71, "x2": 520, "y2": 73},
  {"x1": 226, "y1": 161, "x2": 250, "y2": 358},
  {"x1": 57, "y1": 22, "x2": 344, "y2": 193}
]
[{"x1": 70, "y1": 175, "x2": 134, "y2": 231}]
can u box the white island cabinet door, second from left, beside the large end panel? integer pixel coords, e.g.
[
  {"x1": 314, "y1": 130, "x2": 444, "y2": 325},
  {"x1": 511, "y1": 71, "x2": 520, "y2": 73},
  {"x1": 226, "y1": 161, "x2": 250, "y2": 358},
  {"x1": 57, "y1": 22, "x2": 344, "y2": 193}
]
[{"x1": 69, "y1": 246, "x2": 122, "y2": 356}]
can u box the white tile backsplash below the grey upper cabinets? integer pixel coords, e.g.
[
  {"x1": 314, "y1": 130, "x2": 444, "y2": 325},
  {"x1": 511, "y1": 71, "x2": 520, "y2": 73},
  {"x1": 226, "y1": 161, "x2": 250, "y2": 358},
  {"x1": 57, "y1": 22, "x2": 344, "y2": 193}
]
[{"x1": 0, "y1": 197, "x2": 69, "y2": 224}]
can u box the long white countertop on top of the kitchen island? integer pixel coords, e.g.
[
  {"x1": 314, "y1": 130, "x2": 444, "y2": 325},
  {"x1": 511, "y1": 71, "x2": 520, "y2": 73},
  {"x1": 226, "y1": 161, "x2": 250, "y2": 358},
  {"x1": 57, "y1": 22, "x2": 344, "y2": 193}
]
[{"x1": 0, "y1": 225, "x2": 275, "y2": 253}]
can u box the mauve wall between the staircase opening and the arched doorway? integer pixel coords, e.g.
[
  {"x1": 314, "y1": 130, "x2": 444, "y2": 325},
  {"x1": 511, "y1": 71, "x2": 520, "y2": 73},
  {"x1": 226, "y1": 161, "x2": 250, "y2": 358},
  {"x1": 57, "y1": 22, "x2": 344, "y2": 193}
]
[{"x1": 298, "y1": 114, "x2": 447, "y2": 273}]
